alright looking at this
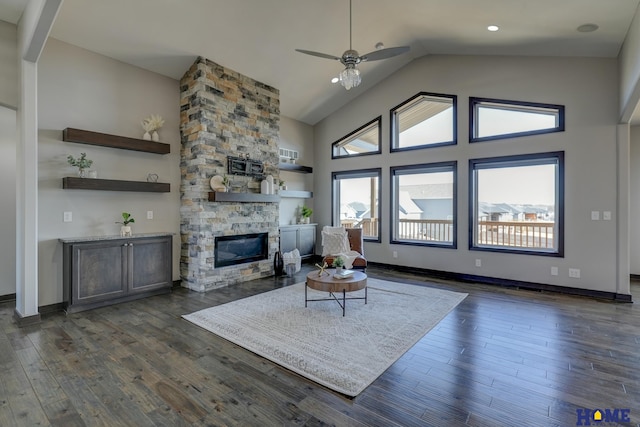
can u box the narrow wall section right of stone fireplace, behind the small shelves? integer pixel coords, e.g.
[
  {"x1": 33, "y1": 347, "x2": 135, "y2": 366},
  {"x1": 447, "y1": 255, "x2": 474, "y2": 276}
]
[{"x1": 279, "y1": 116, "x2": 315, "y2": 225}]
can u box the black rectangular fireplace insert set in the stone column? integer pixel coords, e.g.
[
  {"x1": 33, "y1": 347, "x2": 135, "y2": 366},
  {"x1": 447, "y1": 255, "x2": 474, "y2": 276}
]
[{"x1": 214, "y1": 233, "x2": 269, "y2": 267}]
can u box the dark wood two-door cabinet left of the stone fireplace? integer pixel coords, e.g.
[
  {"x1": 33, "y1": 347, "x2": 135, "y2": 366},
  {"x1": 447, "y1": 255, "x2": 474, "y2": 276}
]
[{"x1": 61, "y1": 235, "x2": 173, "y2": 313}]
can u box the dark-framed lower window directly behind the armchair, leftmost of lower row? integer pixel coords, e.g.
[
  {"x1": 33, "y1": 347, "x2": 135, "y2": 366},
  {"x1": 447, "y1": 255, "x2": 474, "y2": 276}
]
[{"x1": 332, "y1": 169, "x2": 381, "y2": 242}]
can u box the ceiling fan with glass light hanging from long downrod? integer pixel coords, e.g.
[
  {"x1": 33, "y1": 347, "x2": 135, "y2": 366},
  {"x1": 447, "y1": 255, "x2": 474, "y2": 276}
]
[{"x1": 296, "y1": 0, "x2": 409, "y2": 90}]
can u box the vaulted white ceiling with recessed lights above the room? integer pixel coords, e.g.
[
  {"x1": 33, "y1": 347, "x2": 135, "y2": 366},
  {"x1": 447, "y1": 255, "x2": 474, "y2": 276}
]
[{"x1": 0, "y1": 0, "x2": 640, "y2": 124}]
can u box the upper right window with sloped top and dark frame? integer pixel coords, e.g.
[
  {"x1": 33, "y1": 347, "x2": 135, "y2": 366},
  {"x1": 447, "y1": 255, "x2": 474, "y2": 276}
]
[{"x1": 469, "y1": 98, "x2": 564, "y2": 142}]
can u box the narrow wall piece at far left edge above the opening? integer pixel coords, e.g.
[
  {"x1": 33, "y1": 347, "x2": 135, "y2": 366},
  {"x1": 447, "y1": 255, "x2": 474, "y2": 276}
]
[{"x1": 0, "y1": 21, "x2": 19, "y2": 108}]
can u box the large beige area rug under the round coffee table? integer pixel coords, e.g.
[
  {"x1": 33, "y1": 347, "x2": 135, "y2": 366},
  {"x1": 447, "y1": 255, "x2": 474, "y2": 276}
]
[{"x1": 182, "y1": 278, "x2": 467, "y2": 396}]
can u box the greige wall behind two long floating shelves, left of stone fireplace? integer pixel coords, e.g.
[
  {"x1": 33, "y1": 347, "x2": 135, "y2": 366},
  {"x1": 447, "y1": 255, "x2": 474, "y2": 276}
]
[{"x1": 38, "y1": 39, "x2": 180, "y2": 306}]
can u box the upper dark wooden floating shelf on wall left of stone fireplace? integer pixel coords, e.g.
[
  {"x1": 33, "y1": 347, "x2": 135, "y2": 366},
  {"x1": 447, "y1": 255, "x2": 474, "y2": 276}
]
[{"x1": 62, "y1": 128, "x2": 171, "y2": 154}]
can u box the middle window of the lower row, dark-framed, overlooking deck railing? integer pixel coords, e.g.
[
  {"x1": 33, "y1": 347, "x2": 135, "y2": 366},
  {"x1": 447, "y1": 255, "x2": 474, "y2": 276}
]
[{"x1": 391, "y1": 162, "x2": 457, "y2": 248}]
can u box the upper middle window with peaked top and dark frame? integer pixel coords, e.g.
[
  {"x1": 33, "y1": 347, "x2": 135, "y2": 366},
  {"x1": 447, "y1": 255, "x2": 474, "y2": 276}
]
[{"x1": 391, "y1": 92, "x2": 457, "y2": 151}]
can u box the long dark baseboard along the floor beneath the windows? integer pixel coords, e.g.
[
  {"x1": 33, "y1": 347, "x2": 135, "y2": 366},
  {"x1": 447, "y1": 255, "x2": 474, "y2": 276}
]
[{"x1": 369, "y1": 262, "x2": 633, "y2": 303}]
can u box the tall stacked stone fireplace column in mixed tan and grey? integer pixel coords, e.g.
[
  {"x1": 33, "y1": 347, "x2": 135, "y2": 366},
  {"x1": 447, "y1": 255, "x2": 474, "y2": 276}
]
[{"x1": 180, "y1": 58, "x2": 280, "y2": 292}]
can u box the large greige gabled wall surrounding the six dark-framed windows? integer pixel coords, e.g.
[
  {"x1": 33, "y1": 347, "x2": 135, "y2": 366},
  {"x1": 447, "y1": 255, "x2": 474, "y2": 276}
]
[{"x1": 314, "y1": 56, "x2": 619, "y2": 292}]
